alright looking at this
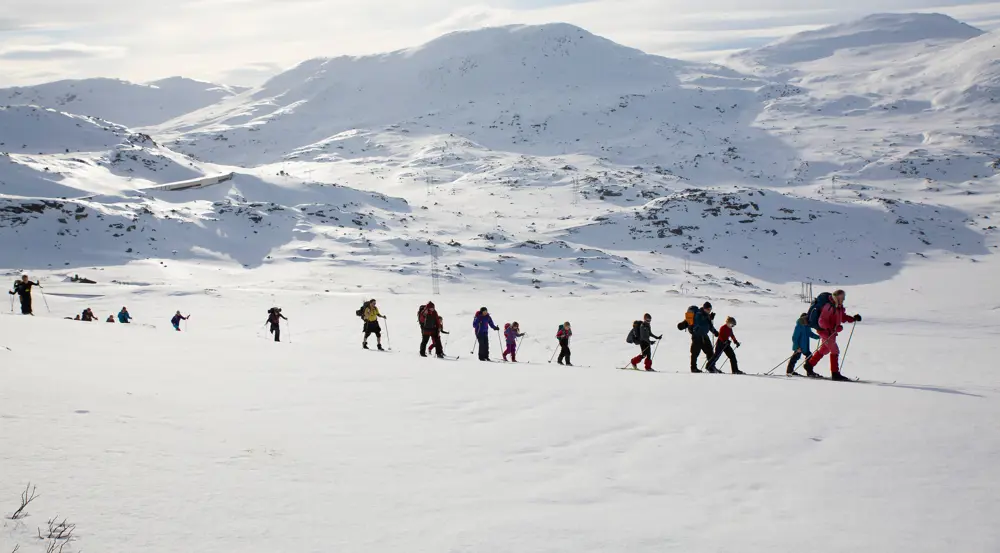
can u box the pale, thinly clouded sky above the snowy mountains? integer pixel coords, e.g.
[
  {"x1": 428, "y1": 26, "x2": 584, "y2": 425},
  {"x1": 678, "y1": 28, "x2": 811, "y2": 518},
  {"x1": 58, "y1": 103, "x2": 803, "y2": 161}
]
[{"x1": 0, "y1": 0, "x2": 1000, "y2": 86}]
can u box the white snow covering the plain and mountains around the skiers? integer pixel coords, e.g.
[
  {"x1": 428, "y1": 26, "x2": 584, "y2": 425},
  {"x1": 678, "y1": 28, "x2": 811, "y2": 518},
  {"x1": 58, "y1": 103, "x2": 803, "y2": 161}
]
[{"x1": 0, "y1": 14, "x2": 1000, "y2": 553}]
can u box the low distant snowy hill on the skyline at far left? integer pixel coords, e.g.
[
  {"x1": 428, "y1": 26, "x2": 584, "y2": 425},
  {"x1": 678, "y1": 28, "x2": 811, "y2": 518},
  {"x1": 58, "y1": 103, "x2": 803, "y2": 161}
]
[{"x1": 0, "y1": 77, "x2": 243, "y2": 127}]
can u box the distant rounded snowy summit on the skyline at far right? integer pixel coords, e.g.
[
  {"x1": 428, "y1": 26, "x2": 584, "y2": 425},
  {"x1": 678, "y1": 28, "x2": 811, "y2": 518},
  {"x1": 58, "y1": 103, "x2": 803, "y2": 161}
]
[{"x1": 730, "y1": 13, "x2": 983, "y2": 68}]
